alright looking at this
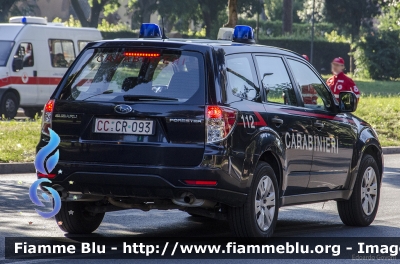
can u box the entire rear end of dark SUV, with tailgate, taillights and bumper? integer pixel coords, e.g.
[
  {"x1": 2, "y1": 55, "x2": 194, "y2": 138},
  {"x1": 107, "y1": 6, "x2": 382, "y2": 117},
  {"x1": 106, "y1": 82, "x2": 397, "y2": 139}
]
[{"x1": 38, "y1": 40, "x2": 245, "y2": 211}]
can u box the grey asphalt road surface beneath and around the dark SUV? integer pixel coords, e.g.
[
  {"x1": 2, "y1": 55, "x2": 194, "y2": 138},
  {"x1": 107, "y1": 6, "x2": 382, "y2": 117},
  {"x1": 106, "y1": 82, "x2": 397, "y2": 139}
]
[{"x1": 0, "y1": 154, "x2": 400, "y2": 264}]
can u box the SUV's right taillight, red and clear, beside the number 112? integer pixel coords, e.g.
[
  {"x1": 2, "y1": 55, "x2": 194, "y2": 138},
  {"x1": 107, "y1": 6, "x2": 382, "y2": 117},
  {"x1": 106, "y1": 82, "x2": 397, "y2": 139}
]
[{"x1": 206, "y1": 105, "x2": 237, "y2": 143}]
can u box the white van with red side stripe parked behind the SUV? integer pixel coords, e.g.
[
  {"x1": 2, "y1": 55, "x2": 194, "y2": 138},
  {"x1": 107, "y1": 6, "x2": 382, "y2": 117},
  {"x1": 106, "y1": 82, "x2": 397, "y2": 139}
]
[{"x1": 0, "y1": 17, "x2": 102, "y2": 118}]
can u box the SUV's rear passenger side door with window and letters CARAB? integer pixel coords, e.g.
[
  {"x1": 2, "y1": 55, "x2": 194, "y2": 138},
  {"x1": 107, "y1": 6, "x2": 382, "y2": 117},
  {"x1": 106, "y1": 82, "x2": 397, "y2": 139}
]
[{"x1": 255, "y1": 55, "x2": 313, "y2": 195}]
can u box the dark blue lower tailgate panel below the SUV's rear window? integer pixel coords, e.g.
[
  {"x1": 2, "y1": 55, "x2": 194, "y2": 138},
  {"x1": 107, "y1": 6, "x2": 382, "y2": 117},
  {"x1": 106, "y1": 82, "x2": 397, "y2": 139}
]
[{"x1": 53, "y1": 102, "x2": 205, "y2": 166}]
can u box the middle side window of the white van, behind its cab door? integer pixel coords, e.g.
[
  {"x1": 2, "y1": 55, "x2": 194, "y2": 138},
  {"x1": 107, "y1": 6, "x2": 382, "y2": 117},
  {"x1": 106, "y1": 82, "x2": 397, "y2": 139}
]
[{"x1": 49, "y1": 39, "x2": 75, "y2": 68}]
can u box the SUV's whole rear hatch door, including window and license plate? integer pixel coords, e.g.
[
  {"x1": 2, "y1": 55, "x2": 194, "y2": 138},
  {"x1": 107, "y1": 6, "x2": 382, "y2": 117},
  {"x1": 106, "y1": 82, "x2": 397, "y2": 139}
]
[{"x1": 53, "y1": 48, "x2": 205, "y2": 166}]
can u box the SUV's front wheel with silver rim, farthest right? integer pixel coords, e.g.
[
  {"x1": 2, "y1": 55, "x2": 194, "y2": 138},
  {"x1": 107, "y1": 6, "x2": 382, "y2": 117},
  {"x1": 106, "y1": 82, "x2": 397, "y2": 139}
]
[{"x1": 337, "y1": 155, "x2": 381, "y2": 226}]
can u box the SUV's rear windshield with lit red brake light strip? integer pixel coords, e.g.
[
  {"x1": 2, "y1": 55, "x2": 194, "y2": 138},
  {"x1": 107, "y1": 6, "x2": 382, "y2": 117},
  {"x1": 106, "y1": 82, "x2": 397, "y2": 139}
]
[{"x1": 60, "y1": 48, "x2": 204, "y2": 102}]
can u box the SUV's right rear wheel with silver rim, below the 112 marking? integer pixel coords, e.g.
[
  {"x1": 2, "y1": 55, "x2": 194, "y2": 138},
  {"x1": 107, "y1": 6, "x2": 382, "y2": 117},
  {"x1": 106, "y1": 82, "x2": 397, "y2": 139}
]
[{"x1": 228, "y1": 161, "x2": 279, "y2": 238}]
